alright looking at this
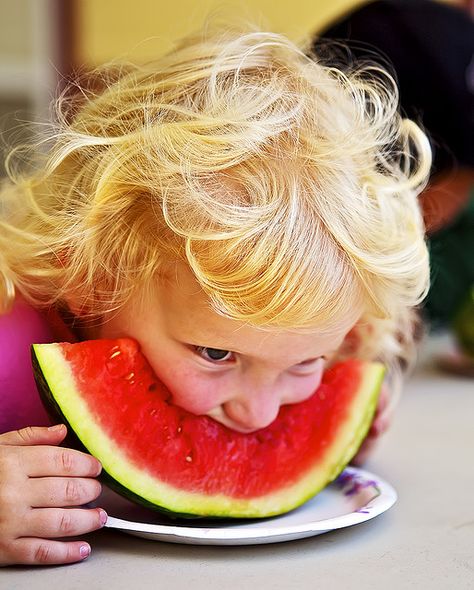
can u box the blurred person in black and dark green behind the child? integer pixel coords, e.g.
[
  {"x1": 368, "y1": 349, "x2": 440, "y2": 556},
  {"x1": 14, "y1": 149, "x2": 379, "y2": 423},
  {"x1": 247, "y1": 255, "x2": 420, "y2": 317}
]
[{"x1": 314, "y1": 0, "x2": 474, "y2": 342}]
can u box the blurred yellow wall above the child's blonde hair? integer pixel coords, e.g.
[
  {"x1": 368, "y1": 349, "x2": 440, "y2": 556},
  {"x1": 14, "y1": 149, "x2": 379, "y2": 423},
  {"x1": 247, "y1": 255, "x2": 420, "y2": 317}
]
[{"x1": 77, "y1": 0, "x2": 367, "y2": 64}]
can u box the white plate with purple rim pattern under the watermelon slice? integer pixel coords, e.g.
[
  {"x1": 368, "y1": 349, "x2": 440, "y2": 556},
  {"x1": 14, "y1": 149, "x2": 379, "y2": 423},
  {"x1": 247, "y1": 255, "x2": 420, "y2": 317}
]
[{"x1": 96, "y1": 467, "x2": 397, "y2": 545}]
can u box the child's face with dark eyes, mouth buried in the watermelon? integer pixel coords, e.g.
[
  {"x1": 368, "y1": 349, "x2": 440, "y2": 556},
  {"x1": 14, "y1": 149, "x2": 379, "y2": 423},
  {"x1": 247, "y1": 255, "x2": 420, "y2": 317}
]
[{"x1": 91, "y1": 267, "x2": 359, "y2": 432}]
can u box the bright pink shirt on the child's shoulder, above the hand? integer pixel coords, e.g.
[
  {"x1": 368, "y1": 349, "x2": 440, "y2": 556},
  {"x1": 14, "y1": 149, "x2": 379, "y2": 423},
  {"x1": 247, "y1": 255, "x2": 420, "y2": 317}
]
[{"x1": 0, "y1": 300, "x2": 70, "y2": 433}]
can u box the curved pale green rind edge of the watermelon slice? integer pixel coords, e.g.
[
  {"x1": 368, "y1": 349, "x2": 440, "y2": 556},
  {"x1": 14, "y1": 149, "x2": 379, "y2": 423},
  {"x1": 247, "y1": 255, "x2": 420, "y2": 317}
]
[{"x1": 32, "y1": 344, "x2": 384, "y2": 518}]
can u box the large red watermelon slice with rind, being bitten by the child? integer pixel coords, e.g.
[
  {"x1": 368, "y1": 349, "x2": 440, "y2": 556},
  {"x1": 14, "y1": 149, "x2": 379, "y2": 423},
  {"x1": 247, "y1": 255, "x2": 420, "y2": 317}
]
[{"x1": 32, "y1": 338, "x2": 384, "y2": 518}]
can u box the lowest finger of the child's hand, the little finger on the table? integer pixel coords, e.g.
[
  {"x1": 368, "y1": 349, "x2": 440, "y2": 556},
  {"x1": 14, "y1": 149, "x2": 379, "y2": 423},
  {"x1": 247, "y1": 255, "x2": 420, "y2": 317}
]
[{"x1": 0, "y1": 538, "x2": 91, "y2": 565}]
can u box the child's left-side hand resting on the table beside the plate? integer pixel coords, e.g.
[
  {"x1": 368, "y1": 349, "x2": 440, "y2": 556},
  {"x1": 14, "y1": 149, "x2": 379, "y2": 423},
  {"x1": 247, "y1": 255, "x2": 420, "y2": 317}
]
[{"x1": 0, "y1": 425, "x2": 107, "y2": 565}]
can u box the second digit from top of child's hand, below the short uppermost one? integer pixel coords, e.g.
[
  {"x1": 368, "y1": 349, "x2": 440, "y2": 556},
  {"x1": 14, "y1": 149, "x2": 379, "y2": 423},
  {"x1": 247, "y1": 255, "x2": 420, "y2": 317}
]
[{"x1": 21, "y1": 446, "x2": 102, "y2": 477}]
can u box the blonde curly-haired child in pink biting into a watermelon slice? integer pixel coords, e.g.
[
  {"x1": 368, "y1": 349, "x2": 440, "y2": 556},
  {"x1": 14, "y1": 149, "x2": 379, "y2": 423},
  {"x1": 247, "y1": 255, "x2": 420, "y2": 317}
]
[{"x1": 0, "y1": 25, "x2": 430, "y2": 564}]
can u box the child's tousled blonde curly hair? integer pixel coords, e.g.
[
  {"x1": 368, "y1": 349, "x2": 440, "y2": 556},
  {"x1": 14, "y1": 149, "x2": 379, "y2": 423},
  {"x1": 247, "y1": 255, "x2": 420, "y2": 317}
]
[{"x1": 0, "y1": 29, "x2": 430, "y2": 374}]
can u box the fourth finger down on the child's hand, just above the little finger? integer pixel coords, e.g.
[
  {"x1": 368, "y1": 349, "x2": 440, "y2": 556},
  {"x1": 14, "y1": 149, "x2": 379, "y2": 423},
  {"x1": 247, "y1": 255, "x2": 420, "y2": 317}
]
[{"x1": 20, "y1": 508, "x2": 107, "y2": 539}]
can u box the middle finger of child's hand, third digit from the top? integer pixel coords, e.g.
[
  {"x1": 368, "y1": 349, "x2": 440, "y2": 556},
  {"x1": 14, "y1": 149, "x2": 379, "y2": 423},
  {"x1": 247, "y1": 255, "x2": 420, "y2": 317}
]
[{"x1": 27, "y1": 477, "x2": 102, "y2": 508}]
